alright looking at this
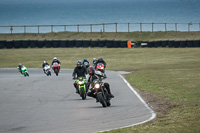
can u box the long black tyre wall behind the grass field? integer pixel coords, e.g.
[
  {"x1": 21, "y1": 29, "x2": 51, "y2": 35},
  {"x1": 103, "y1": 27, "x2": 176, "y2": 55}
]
[{"x1": 0, "y1": 40, "x2": 200, "y2": 49}]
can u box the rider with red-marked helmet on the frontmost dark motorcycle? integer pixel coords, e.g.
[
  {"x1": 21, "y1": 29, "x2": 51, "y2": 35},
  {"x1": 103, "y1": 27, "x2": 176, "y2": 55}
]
[{"x1": 87, "y1": 67, "x2": 114, "y2": 102}]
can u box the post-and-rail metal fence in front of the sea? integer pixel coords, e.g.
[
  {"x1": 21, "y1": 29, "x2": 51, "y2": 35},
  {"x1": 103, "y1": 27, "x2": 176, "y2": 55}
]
[{"x1": 0, "y1": 23, "x2": 200, "y2": 34}]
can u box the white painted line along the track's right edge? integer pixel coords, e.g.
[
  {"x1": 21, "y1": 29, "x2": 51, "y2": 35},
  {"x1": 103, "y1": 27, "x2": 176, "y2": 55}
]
[{"x1": 98, "y1": 74, "x2": 156, "y2": 132}]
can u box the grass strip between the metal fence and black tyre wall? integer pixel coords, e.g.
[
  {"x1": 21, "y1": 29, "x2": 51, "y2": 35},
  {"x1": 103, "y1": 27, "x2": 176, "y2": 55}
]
[{"x1": 0, "y1": 31, "x2": 200, "y2": 41}]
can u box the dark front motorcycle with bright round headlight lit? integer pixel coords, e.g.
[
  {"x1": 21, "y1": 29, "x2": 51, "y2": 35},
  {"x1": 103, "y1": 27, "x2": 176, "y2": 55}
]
[{"x1": 93, "y1": 72, "x2": 111, "y2": 107}]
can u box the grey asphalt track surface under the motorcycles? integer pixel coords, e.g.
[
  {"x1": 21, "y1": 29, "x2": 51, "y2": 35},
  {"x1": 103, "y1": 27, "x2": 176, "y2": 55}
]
[{"x1": 0, "y1": 68, "x2": 155, "y2": 133}]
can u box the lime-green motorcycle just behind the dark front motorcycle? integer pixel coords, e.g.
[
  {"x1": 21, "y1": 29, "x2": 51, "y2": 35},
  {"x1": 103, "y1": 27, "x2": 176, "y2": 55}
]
[{"x1": 76, "y1": 77, "x2": 87, "y2": 100}]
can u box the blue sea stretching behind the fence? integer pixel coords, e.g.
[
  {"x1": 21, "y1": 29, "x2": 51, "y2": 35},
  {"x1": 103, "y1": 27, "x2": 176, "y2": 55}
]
[{"x1": 0, "y1": 0, "x2": 200, "y2": 33}]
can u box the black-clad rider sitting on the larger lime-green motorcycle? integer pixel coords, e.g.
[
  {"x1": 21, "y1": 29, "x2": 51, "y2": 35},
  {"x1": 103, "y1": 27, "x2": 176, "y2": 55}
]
[{"x1": 72, "y1": 60, "x2": 87, "y2": 93}]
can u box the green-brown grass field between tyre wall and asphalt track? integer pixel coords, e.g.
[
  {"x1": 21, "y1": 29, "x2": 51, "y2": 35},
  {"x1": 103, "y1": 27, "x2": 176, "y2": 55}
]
[{"x1": 0, "y1": 48, "x2": 200, "y2": 133}]
